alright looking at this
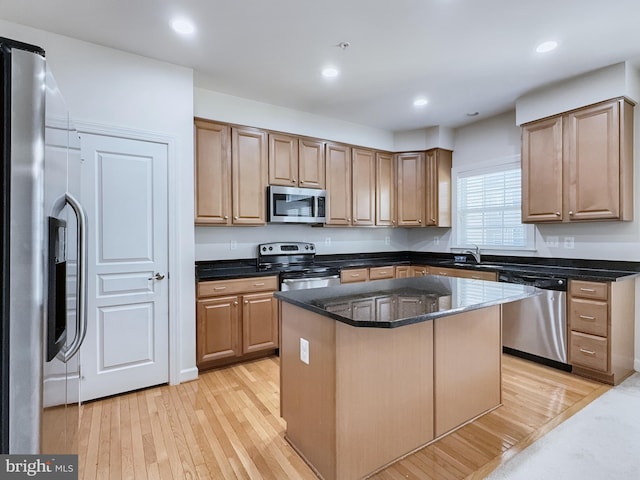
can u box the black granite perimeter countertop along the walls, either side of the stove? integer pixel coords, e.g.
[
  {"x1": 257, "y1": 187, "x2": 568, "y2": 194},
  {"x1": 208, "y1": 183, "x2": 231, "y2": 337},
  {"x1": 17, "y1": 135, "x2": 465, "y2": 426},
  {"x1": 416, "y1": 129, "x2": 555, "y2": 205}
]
[{"x1": 196, "y1": 252, "x2": 640, "y2": 282}]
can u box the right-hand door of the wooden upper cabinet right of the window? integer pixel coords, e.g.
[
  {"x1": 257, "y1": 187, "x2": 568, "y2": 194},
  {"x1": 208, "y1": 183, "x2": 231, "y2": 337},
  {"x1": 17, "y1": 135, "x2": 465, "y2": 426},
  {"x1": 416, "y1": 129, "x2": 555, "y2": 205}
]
[{"x1": 564, "y1": 101, "x2": 620, "y2": 220}]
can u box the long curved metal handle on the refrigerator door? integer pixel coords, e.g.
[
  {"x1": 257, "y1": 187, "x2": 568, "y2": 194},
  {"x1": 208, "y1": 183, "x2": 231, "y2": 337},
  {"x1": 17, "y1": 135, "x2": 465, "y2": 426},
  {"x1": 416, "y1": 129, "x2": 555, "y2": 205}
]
[{"x1": 58, "y1": 193, "x2": 87, "y2": 363}]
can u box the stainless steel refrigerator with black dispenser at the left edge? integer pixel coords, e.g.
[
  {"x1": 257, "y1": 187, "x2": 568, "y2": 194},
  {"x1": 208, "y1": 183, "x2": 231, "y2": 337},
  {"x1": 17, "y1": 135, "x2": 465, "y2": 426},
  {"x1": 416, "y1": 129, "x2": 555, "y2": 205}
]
[{"x1": 0, "y1": 38, "x2": 87, "y2": 454}]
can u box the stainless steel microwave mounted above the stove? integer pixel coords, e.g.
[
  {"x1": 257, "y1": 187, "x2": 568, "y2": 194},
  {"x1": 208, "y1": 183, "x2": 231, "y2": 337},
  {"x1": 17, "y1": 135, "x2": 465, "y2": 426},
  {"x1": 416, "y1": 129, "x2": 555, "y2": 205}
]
[{"x1": 267, "y1": 185, "x2": 327, "y2": 223}]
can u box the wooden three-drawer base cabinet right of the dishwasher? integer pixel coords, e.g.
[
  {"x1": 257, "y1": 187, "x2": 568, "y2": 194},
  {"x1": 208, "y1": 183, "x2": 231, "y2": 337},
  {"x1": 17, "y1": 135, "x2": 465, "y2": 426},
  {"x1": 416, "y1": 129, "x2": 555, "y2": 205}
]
[{"x1": 567, "y1": 280, "x2": 635, "y2": 385}]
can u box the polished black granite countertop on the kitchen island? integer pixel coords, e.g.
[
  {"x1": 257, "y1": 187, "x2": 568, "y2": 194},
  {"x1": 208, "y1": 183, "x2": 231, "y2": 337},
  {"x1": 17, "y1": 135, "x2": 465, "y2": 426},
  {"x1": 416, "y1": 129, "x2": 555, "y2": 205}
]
[{"x1": 274, "y1": 276, "x2": 541, "y2": 328}]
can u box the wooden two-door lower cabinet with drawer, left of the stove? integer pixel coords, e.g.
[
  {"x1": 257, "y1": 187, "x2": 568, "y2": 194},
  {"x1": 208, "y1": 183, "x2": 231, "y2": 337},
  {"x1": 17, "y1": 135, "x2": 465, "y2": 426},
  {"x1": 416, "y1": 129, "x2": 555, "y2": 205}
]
[{"x1": 196, "y1": 276, "x2": 278, "y2": 370}]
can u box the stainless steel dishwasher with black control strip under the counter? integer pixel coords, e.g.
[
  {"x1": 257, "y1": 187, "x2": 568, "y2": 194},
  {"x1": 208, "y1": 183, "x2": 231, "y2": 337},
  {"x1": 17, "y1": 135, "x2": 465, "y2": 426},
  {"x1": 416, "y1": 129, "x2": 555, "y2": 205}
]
[{"x1": 498, "y1": 272, "x2": 571, "y2": 371}]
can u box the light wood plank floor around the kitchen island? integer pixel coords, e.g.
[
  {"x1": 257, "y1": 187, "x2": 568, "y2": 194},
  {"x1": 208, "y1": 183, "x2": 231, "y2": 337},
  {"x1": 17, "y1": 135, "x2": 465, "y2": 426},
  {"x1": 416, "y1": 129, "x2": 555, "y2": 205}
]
[{"x1": 79, "y1": 355, "x2": 609, "y2": 480}]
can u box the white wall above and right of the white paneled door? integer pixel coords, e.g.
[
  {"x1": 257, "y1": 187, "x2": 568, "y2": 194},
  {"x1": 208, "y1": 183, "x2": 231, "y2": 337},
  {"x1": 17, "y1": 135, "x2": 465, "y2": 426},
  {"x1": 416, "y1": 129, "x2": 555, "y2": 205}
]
[{"x1": 0, "y1": 20, "x2": 197, "y2": 379}]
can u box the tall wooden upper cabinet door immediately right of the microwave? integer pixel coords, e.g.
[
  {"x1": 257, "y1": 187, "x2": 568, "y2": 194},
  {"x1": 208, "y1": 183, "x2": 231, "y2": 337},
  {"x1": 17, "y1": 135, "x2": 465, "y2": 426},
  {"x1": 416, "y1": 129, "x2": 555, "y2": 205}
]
[{"x1": 326, "y1": 143, "x2": 351, "y2": 225}]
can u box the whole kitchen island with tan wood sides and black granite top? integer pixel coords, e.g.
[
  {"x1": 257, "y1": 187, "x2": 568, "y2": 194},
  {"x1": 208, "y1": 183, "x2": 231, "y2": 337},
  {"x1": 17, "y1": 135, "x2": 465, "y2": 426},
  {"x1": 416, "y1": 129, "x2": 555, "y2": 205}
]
[{"x1": 276, "y1": 276, "x2": 537, "y2": 480}]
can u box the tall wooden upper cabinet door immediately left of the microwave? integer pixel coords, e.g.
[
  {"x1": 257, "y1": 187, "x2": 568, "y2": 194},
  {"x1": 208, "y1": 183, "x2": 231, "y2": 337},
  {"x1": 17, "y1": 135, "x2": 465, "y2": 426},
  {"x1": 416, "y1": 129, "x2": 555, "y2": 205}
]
[{"x1": 231, "y1": 127, "x2": 268, "y2": 225}]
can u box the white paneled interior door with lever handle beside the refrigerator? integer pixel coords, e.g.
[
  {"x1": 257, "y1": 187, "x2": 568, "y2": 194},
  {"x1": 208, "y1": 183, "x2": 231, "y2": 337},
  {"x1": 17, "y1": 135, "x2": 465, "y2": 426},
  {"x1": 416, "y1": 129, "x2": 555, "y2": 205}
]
[{"x1": 80, "y1": 134, "x2": 169, "y2": 400}]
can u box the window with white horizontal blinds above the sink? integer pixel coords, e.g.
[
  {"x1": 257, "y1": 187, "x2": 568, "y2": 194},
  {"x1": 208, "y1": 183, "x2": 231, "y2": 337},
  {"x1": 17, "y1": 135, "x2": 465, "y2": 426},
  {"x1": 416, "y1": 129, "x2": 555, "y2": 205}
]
[{"x1": 456, "y1": 157, "x2": 534, "y2": 250}]
